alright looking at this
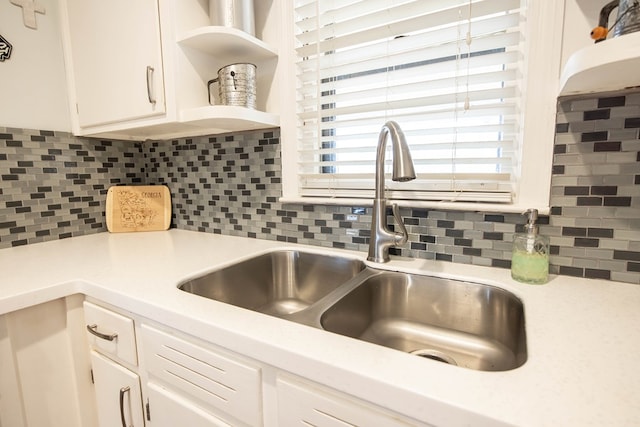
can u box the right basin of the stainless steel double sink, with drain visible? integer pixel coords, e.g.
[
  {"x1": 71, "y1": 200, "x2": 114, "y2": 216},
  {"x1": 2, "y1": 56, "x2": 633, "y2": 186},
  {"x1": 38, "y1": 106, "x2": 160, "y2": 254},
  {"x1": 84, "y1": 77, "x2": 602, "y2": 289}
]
[{"x1": 320, "y1": 272, "x2": 527, "y2": 371}]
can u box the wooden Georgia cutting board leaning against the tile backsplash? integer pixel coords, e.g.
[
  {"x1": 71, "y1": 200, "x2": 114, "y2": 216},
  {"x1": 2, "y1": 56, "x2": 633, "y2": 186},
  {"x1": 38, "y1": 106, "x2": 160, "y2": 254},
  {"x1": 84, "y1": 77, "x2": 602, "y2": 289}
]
[{"x1": 106, "y1": 185, "x2": 171, "y2": 233}]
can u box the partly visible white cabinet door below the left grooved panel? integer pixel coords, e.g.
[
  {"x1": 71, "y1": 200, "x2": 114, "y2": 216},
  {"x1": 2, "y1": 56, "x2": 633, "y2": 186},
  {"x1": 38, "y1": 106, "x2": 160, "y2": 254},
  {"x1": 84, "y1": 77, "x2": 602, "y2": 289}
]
[{"x1": 147, "y1": 383, "x2": 231, "y2": 427}]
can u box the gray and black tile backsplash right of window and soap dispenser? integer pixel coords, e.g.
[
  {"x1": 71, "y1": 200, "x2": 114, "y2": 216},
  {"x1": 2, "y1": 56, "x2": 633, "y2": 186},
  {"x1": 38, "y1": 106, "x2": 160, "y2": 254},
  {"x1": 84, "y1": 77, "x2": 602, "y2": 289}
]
[{"x1": 546, "y1": 91, "x2": 640, "y2": 283}]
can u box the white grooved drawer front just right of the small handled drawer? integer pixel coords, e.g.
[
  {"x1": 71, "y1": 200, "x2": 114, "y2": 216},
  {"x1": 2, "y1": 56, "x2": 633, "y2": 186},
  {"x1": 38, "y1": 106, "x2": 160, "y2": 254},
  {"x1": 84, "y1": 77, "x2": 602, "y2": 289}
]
[{"x1": 140, "y1": 324, "x2": 262, "y2": 425}]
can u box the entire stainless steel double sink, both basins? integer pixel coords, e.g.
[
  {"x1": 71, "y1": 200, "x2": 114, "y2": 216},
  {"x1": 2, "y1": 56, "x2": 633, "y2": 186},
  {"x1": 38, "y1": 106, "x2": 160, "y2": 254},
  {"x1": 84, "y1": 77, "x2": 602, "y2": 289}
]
[{"x1": 178, "y1": 250, "x2": 527, "y2": 371}]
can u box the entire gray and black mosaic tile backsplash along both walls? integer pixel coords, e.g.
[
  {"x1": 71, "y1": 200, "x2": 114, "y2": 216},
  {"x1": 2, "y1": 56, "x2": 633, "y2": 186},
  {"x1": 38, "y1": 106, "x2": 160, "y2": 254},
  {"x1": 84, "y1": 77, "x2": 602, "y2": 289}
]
[{"x1": 0, "y1": 91, "x2": 640, "y2": 284}]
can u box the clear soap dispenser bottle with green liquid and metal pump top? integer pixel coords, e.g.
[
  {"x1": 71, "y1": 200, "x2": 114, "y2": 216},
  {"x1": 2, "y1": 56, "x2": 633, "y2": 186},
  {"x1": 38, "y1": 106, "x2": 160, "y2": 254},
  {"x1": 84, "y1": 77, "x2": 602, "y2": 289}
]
[{"x1": 511, "y1": 209, "x2": 549, "y2": 284}]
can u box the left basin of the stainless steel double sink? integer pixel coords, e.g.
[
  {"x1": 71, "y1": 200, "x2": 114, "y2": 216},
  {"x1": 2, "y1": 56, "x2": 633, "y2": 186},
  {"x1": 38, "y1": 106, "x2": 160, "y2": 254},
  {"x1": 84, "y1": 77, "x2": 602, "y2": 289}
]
[{"x1": 179, "y1": 250, "x2": 365, "y2": 317}]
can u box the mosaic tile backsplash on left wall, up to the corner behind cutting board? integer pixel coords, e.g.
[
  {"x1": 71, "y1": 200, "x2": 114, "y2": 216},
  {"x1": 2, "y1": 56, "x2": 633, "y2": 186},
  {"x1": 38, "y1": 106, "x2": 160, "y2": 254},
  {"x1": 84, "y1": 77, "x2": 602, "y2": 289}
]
[{"x1": 0, "y1": 127, "x2": 143, "y2": 248}]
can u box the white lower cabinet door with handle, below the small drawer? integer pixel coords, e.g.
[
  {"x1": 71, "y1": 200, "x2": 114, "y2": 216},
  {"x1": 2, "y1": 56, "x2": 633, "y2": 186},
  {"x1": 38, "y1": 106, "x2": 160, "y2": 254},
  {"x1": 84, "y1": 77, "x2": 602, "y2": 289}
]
[{"x1": 91, "y1": 350, "x2": 144, "y2": 427}]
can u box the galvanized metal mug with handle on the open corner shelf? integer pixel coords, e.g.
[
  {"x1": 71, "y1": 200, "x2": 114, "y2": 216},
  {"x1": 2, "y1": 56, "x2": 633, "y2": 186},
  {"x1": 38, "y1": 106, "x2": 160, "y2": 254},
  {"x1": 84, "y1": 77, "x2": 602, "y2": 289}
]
[{"x1": 208, "y1": 64, "x2": 256, "y2": 110}]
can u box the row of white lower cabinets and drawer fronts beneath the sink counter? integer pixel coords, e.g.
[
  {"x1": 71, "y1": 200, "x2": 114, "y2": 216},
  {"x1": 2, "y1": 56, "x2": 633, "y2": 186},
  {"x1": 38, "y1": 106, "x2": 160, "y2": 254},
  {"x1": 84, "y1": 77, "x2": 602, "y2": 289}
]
[{"x1": 84, "y1": 303, "x2": 426, "y2": 427}]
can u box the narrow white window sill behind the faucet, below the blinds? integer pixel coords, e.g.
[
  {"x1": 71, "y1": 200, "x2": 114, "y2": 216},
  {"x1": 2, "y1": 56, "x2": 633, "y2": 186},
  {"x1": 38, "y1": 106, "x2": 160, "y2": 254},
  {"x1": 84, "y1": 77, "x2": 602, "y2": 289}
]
[{"x1": 279, "y1": 197, "x2": 550, "y2": 215}]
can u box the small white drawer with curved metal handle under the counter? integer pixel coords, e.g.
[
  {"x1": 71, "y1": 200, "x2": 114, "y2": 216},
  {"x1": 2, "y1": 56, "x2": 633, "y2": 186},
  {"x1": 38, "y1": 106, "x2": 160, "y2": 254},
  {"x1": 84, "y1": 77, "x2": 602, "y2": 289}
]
[{"x1": 84, "y1": 301, "x2": 138, "y2": 366}]
